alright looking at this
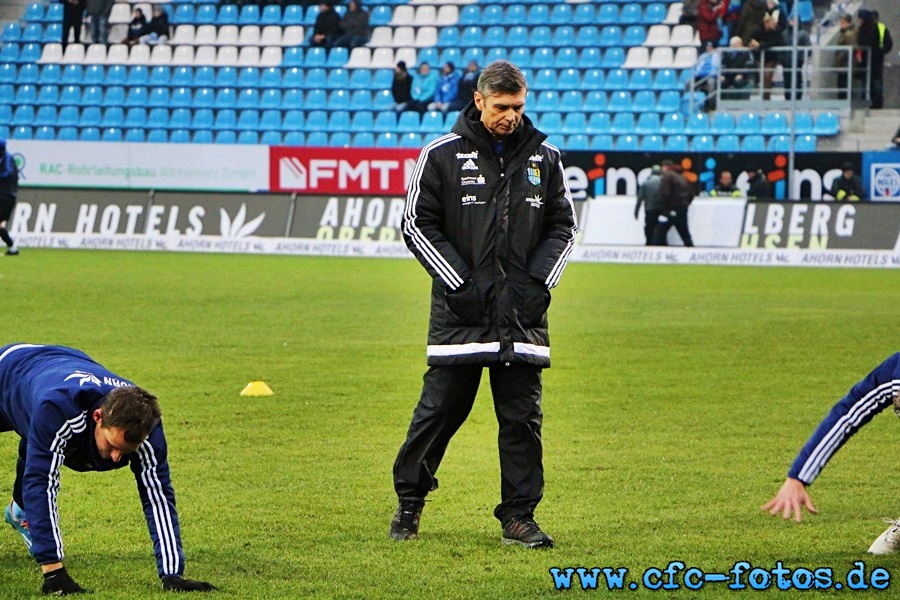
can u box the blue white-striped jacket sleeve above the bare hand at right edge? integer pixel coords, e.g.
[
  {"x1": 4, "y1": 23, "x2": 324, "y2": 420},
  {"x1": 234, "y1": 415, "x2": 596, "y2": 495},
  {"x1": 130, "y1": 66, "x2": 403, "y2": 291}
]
[{"x1": 788, "y1": 353, "x2": 900, "y2": 485}]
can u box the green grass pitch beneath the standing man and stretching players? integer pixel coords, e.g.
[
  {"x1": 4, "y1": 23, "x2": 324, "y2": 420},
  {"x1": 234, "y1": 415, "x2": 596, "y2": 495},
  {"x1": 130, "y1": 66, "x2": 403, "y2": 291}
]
[{"x1": 0, "y1": 250, "x2": 900, "y2": 600}]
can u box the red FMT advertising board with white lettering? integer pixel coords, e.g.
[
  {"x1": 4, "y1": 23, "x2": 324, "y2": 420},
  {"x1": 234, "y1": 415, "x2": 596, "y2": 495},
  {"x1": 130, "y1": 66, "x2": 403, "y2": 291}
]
[{"x1": 269, "y1": 146, "x2": 419, "y2": 196}]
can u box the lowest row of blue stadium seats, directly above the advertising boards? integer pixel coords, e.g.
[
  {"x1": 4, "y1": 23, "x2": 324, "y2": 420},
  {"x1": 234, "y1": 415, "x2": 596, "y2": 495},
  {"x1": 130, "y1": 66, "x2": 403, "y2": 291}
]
[{"x1": 0, "y1": 126, "x2": 816, "y2": 152}]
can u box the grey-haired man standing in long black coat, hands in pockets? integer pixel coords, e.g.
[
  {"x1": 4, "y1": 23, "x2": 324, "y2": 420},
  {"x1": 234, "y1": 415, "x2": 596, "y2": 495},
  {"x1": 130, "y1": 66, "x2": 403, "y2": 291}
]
[{"x1": 390, "y1": 60, "x2": 576, "y2": 548}]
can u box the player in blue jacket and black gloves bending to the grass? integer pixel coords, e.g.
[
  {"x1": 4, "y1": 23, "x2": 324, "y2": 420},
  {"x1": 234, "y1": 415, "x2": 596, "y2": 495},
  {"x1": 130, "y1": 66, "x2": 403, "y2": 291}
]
[{"x1": 0, "y1": 344, "x2": 215, "y2": 595}]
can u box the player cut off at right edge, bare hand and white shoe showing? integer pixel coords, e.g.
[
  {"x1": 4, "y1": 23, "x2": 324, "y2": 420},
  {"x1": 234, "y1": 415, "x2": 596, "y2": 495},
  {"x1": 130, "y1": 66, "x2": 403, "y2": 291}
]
[{"x1": 762, "y1": 353, "x2": 900, "y2": 554}]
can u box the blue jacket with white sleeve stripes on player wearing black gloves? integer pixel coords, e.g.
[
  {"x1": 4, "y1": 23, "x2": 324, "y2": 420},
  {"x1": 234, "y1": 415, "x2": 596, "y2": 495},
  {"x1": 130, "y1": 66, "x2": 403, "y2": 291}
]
[{"x1": 0, "y1": 344, "x2": 184, "y2": 577}]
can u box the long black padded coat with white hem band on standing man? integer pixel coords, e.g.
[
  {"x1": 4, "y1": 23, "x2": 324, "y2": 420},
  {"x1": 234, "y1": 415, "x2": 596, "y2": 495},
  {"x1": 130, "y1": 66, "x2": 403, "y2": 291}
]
[{"x1": 403, "y1": 102, "x2": 576, "y2": 367}]
